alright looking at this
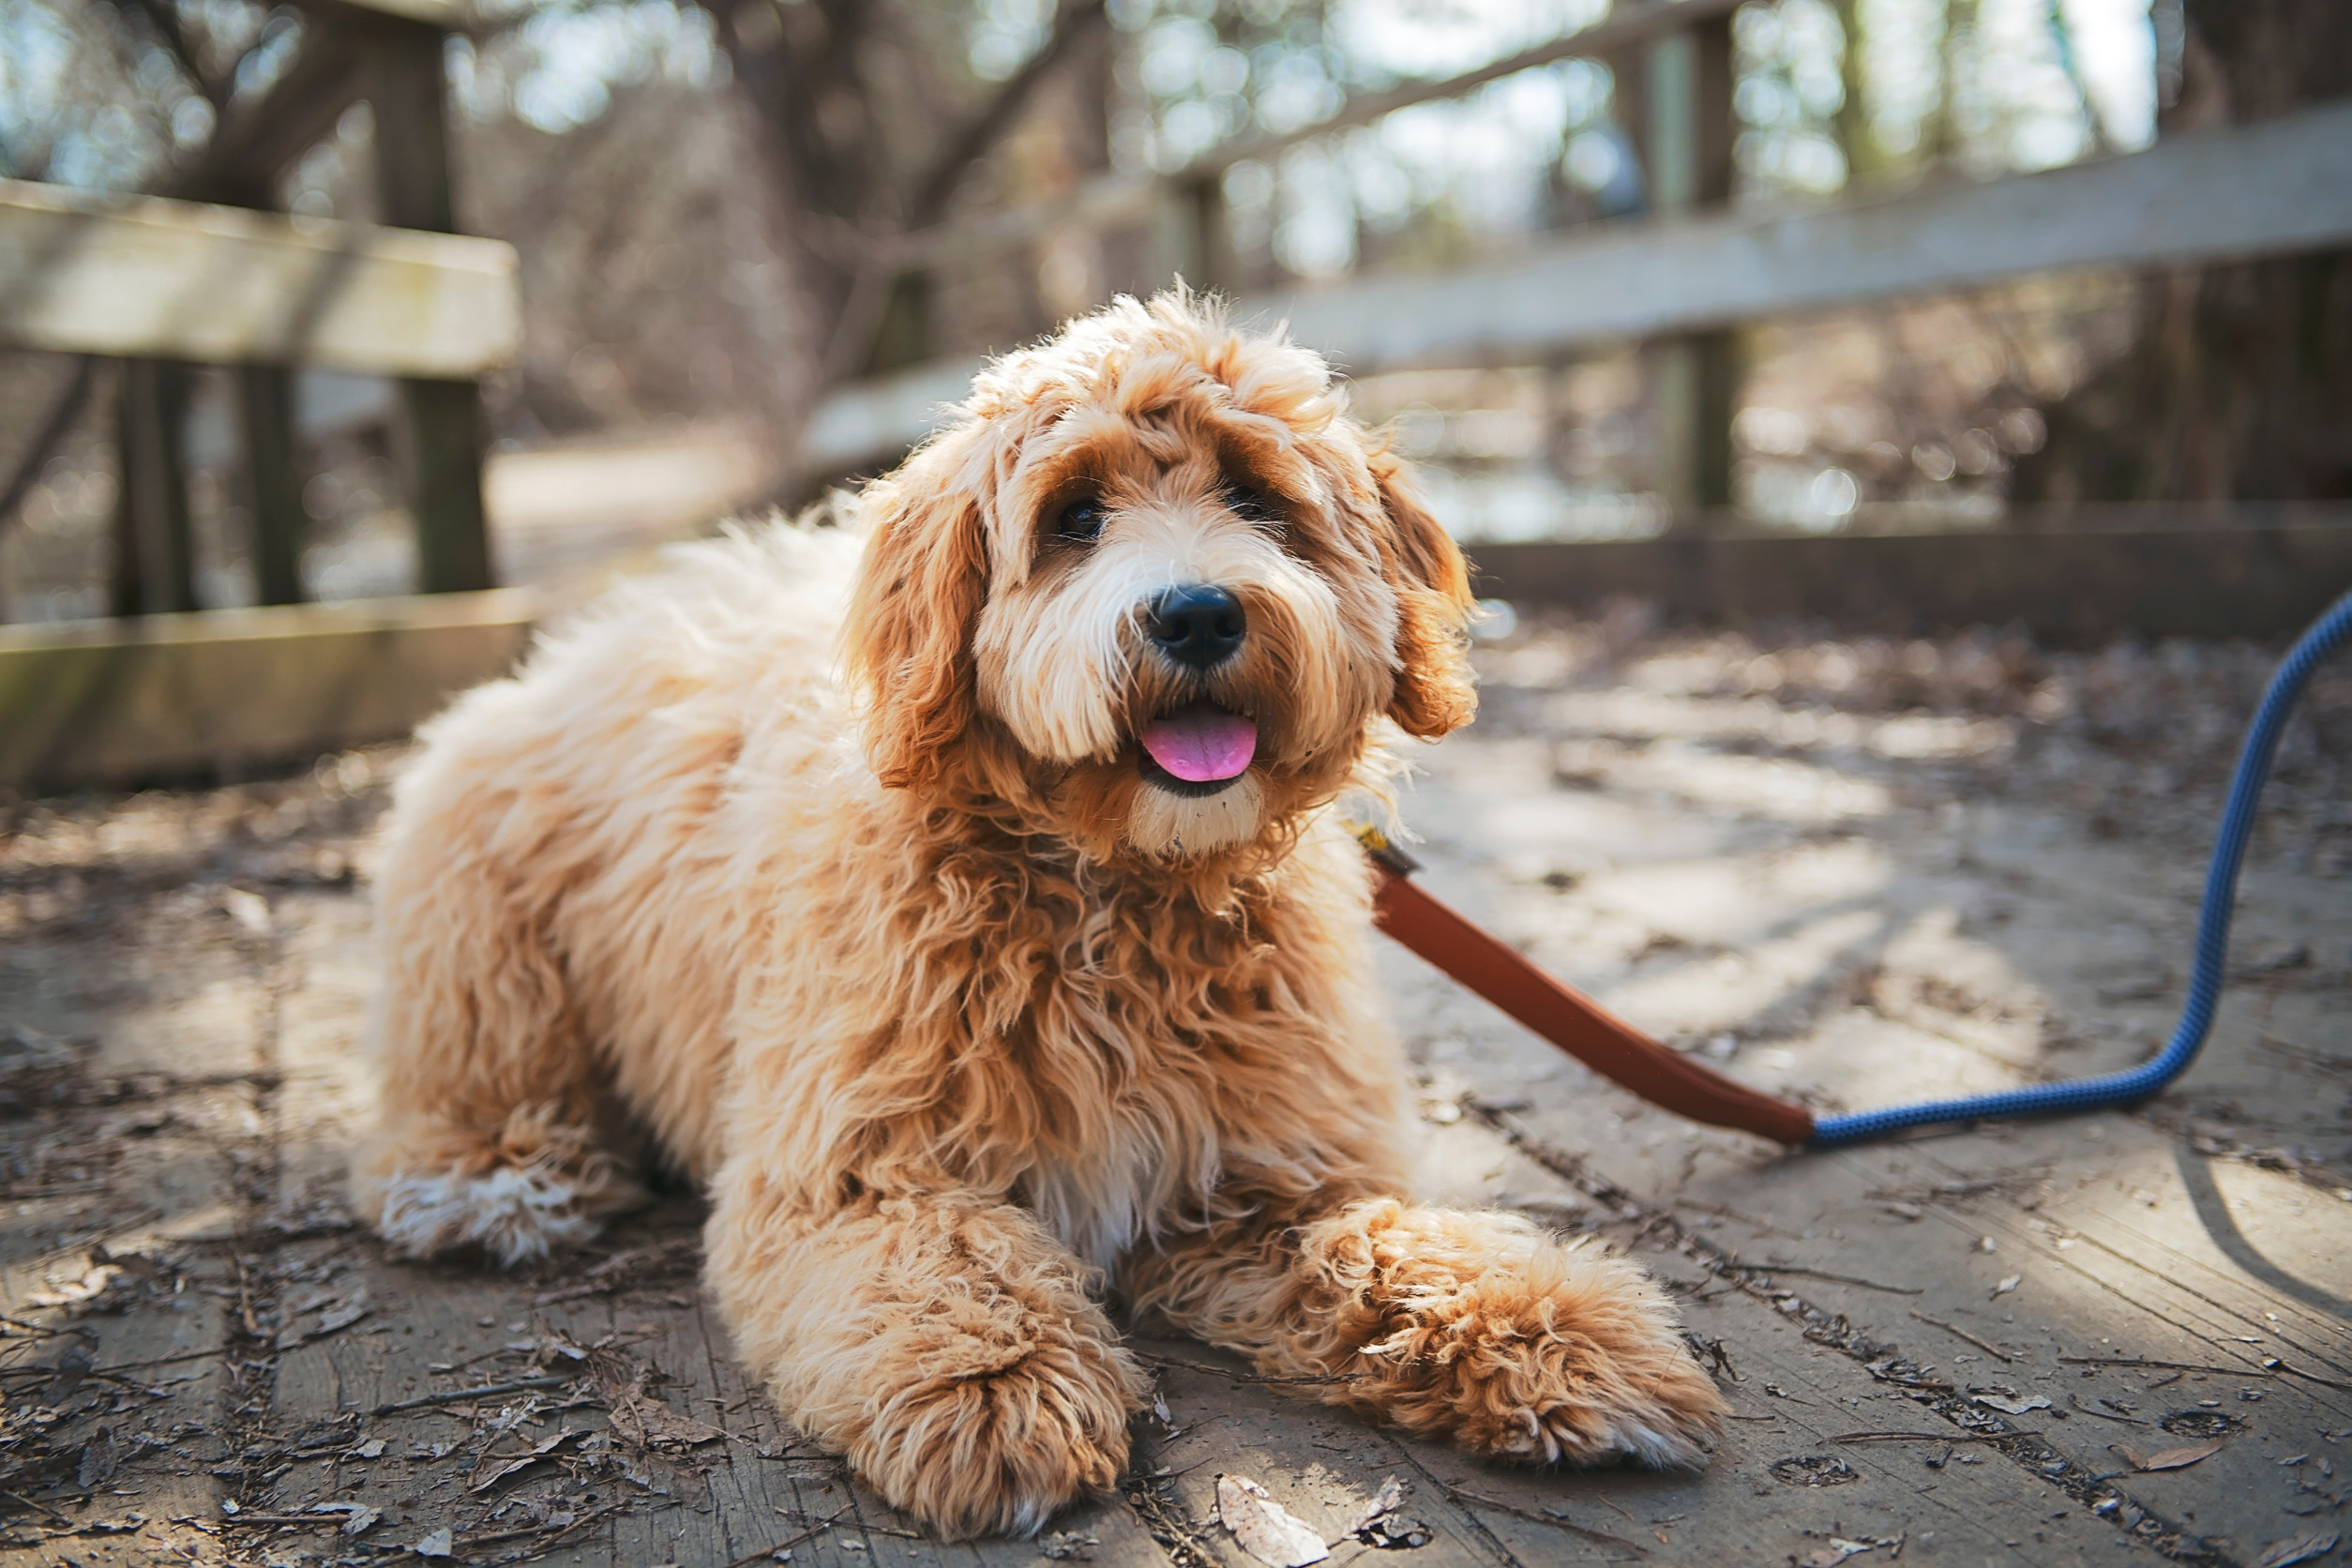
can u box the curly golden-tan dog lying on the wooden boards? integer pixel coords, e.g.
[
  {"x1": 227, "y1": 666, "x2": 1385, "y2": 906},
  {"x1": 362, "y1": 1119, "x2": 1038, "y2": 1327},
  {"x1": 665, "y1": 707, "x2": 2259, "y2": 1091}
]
[{"x1": 355, "y1": 289, "x2": 1724, "y2": 1537}]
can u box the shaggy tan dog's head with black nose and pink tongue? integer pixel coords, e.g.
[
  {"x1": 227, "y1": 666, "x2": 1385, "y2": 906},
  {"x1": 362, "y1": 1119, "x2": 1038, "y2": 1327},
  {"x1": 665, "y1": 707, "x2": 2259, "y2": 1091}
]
[{"x1": 844, "y1": 292, "x2": 1475, "y2": 860}]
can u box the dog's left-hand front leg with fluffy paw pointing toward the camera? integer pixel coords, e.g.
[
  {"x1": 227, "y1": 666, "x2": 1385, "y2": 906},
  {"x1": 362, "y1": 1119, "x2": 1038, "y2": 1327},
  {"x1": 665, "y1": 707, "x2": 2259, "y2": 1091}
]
[{"x1": 708, "y1": 1189, "x2": 1148, "y2": 1537}]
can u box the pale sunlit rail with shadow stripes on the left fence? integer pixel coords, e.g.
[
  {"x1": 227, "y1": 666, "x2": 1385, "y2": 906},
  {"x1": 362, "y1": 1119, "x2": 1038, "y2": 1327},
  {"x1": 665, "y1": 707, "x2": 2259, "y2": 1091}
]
[{"x1": 0, "y1": 181, "x2": 522, "y2": 379}]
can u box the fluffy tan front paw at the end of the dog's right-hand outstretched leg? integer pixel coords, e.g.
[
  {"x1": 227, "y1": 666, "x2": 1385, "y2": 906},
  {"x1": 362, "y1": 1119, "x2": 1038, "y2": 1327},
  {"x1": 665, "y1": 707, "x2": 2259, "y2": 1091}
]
[{"x1": 1298, "y1": 1206, "x2": 1724, "y2": 1465}]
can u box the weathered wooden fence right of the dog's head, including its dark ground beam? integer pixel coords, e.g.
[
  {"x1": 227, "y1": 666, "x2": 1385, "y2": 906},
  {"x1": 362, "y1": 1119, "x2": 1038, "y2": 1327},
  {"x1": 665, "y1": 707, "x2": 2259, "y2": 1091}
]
[{"x1": 800, "y1": 0, "x2": 2352, "y2": 640}]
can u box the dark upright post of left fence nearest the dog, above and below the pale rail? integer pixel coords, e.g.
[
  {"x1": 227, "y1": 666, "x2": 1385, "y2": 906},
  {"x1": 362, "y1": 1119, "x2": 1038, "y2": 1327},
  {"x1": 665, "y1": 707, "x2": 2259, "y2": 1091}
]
[{"x1": 365, "y1": 17, "x2": 491, "y2": 593}]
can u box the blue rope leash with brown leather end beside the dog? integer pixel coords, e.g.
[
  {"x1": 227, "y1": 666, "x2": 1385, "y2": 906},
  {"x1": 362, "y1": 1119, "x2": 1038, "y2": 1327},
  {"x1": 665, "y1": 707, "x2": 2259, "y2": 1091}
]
[{"x1": 1355, "y1": 593, "x2": 2352, "y2": 1150}]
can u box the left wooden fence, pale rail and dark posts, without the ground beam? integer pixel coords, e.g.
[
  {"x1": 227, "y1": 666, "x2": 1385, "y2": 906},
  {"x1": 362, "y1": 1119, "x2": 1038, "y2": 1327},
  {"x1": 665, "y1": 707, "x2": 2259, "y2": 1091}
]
[{"x1": 0, "y1": 0, "x2": 522, "y2": 613}]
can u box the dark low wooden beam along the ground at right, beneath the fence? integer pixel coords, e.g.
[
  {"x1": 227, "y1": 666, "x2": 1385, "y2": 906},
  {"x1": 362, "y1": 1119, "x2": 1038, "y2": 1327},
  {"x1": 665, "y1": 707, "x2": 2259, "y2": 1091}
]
[{"x1": 1470, "y1": 503, "x2": 2352, "y2": 641}]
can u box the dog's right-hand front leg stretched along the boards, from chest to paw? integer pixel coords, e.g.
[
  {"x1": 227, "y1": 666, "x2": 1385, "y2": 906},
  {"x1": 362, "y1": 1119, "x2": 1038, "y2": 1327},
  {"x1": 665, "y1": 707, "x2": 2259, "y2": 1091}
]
[{"x1": 1122, "y1": 1194, "x2": 1724, "y2": 1465}]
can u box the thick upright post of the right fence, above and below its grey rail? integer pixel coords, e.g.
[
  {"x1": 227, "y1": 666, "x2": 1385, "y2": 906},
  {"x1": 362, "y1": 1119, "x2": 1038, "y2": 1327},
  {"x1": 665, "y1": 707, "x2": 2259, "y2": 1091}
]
[{"x1": 1635, "y1": 14, "x2": 1741, "y2": 515}]
